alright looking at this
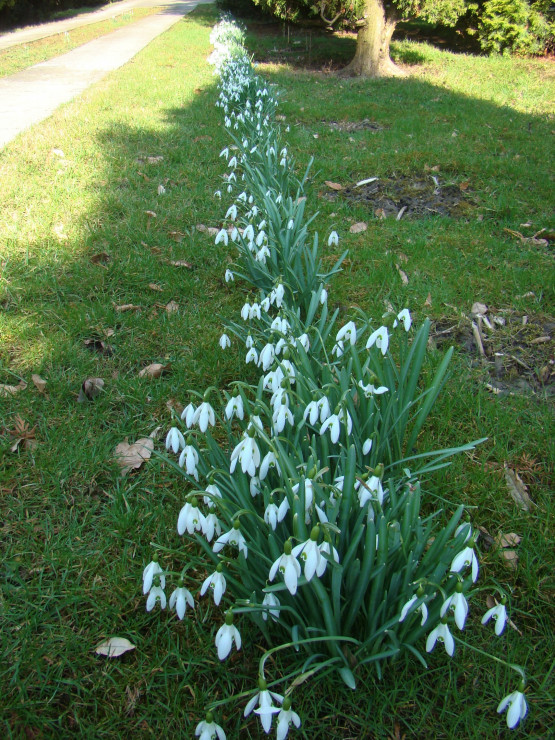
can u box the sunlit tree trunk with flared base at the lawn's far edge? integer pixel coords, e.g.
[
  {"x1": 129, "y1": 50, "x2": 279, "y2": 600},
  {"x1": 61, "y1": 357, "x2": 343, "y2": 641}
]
[{"x1": 340, "y1": 0, "x2": 404, "y2": 77}]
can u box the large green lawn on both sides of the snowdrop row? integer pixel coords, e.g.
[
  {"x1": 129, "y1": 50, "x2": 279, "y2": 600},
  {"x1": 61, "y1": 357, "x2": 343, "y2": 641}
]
[{"x1": 0, "y1": 8, "x2": 554, "y2": 738}]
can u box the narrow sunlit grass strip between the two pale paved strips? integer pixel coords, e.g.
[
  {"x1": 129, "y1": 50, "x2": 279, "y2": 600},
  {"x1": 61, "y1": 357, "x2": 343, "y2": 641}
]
[{"x1": 0, "y1": 8, "x2": 164, "y2": 77}]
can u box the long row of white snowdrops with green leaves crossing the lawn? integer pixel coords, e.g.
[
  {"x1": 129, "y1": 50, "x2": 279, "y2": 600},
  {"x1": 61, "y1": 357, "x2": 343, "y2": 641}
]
[{"x1": 139, "y1": 19, "x2": 527, "y2": 740}]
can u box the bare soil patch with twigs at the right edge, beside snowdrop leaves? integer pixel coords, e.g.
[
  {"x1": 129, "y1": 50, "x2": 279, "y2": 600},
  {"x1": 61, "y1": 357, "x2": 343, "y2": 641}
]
[{"x1": 430, "y1": 304, "x2": 555, "y2": 398}]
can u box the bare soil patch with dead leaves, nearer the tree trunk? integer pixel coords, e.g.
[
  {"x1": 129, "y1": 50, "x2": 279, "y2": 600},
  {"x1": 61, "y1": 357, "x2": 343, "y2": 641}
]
[{"x1": 327, "y1": 175, "x2": 475, "y2": 219}]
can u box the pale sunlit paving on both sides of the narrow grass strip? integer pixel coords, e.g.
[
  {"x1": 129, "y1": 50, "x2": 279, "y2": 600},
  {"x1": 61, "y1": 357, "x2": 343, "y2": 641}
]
[{"x1": 0, "y1": 0, "x2": 211, "y2": 148}]
